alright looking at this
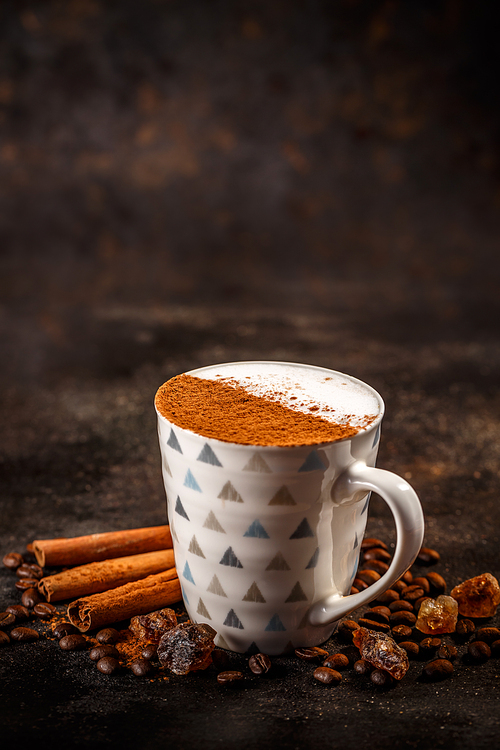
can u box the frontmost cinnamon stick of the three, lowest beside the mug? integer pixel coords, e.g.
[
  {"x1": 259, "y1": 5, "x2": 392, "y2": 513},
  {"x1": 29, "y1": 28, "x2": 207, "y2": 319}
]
[{"x1": 68, "y1": 568, "x2": 182, "y2": 633}]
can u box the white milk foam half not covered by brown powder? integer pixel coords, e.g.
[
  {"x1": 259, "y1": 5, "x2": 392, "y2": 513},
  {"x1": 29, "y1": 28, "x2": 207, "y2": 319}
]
[{"x1": 193, "y1": 362, "x2": 381, "y2": 428}]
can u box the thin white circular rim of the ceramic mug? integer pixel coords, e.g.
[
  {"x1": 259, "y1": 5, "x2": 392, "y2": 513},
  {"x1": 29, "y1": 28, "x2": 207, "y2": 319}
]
[{"x1": 153, "y1": 359, "x2": 385, "y2": 450}]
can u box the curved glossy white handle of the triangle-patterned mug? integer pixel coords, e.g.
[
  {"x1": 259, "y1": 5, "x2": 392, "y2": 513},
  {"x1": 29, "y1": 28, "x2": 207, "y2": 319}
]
[{"x1": 309, "y1": 461, "x2": 424, "y2": 625}]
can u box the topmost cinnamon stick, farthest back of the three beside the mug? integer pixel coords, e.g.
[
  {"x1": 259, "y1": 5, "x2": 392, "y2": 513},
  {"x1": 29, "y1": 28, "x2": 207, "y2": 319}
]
[{"x1": 33, "y1": 526, "x2": 172, "y2": 568}]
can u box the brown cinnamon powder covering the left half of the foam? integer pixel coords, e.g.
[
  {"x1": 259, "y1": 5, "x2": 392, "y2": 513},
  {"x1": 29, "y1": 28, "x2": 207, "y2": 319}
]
[{"x1": 155, "y1": 375, "x2": 376, "y2": 446}]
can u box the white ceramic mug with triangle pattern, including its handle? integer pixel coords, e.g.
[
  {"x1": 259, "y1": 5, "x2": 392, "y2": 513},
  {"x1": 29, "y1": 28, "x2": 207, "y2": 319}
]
[{"x1": 157, "y1": 362, "x2": 424, "y2": 654}]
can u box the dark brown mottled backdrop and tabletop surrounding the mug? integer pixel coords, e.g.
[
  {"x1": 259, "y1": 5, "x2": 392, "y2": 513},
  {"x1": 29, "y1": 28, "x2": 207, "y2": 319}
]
[{"x1": 0, "y1": 0, "x2": 500, "y2": 750}]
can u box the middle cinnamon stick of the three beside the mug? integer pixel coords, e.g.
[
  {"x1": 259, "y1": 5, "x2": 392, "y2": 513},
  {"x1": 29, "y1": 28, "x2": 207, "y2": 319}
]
[{"x1": 38, "y1": 549, "x2": 175, "y2": 602}]
